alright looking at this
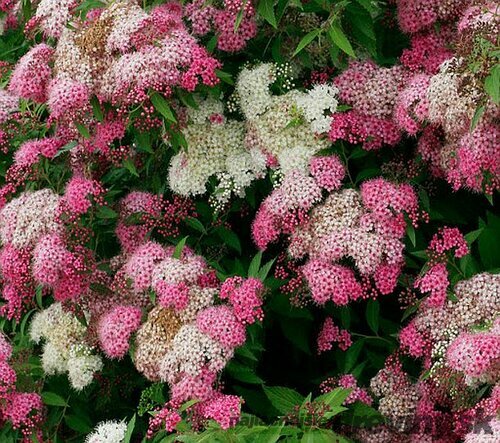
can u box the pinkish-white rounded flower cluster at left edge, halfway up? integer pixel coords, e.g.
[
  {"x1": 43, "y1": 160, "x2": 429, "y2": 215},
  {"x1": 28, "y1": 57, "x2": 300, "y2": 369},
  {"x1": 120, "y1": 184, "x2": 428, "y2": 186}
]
[{"x1": 0, "y1": 189, "x2": 61, "y2": 248}]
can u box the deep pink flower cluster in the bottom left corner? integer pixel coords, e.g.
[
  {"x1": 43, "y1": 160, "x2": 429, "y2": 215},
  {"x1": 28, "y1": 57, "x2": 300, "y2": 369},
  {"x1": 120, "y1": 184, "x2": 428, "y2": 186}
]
[{"x1": 0, "y1": 335, "x2": 43, "y2": 442}]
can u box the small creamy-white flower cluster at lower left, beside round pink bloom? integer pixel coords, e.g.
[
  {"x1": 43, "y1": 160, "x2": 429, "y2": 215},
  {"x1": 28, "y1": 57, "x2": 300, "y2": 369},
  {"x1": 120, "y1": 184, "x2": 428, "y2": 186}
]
[{"x1": 30, "y1": 303, "x2": 102, "y2": 390}]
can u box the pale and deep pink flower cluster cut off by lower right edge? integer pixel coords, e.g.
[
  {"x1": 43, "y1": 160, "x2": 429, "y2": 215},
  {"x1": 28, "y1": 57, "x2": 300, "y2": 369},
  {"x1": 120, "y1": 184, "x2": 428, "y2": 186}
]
[{"x1": 399, "y1": 272, "x2": 500, "y2": 384}]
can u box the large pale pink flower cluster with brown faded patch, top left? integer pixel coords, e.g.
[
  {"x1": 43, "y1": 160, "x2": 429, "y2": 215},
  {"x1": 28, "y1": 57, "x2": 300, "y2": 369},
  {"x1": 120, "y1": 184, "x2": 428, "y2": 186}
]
[{"x1": 47, "y1": 1, "x2": 220, "y2": 120}]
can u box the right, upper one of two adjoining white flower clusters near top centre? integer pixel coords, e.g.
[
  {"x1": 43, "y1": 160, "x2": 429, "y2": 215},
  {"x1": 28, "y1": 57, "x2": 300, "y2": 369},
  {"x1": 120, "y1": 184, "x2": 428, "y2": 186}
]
[{"x1": 236, "y1": 64, "x2": 337, "y2": 174}]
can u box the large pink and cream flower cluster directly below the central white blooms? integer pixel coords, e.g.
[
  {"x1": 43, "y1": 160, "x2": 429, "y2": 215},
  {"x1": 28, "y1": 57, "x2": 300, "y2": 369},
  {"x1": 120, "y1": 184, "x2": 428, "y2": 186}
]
[{"x1": 252, "y1": 174, "x2": 418, "y2": 305}]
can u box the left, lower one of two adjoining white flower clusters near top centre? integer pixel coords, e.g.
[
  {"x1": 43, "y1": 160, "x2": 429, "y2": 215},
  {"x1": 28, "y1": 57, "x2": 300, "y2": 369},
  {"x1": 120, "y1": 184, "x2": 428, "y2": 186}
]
[{"x1": 168, "y1": 99, "x2": 265, "y2": 205}]
